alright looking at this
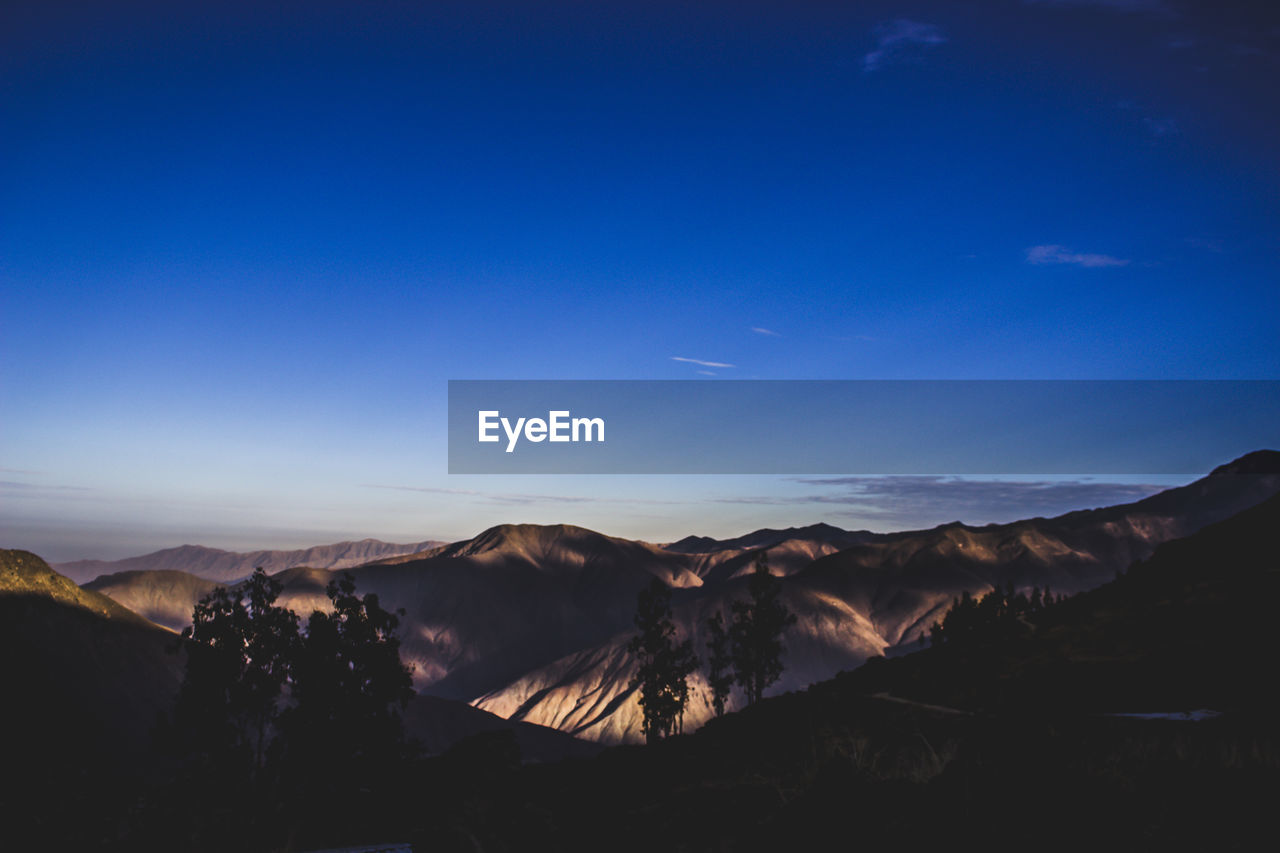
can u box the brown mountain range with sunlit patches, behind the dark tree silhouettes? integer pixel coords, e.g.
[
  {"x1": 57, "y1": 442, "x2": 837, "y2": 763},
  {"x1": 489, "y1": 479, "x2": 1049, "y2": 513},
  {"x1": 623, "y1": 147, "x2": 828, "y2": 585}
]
[{"x1": 74, "y1": 451, "x2": 1280, "y2": 743}]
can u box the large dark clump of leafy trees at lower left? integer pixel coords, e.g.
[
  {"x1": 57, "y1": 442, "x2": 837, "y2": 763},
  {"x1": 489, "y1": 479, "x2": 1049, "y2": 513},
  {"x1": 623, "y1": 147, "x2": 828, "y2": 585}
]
[{"x1": 160, "y1": 569, "x2": 413, "y2": 849}]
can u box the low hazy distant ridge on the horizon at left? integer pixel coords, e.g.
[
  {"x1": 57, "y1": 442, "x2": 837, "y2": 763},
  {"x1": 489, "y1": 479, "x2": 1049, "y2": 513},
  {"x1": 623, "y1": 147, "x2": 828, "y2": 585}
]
[{"x1": 54, "y1": 539, "x2": 444, "y2": 583}]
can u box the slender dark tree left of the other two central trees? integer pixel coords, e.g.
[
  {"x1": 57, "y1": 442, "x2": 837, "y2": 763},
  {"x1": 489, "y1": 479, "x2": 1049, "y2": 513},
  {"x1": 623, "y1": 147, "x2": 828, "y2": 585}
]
[{"x1": 627, "y1": 578, "x2": 698, "y2": 743}]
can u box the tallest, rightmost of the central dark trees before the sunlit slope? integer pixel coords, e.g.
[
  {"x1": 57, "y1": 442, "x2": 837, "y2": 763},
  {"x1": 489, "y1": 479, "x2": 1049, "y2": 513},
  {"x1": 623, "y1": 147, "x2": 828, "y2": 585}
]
[{"x1": 730, "y1": 551, "x2": 796, "y2": 704}]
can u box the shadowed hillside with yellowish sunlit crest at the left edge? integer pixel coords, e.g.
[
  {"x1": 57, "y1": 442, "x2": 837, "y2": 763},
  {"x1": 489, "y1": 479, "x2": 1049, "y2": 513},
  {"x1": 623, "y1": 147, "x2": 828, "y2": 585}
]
[{"x1": 0, "y1": 551, "x2": 183, "y2": 849}]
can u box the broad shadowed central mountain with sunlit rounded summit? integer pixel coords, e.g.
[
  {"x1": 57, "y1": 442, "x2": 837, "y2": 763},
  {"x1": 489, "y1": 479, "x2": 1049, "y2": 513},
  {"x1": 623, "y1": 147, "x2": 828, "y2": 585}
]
[{"x1": 282, "y1": 524, "x2": 701, "y2": 699}]
